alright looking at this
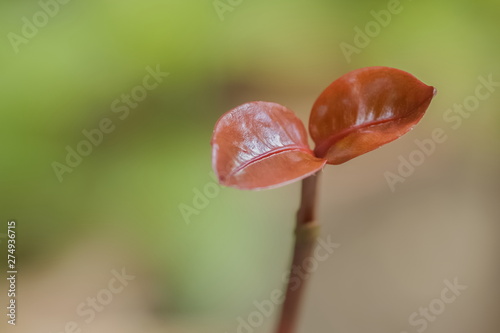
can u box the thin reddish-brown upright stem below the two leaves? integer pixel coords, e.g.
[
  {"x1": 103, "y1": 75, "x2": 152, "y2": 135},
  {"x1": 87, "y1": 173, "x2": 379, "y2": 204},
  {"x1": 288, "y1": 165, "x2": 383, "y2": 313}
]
[{"x1": 276, "y1": 174, "x2": 319, "y2": 333}]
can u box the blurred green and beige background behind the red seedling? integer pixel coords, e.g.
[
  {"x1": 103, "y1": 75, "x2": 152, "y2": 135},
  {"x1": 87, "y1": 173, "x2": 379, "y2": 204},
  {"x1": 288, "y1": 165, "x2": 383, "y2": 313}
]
[{"x1": 0, "y1": 0, "x2": 500, "y2": 333}]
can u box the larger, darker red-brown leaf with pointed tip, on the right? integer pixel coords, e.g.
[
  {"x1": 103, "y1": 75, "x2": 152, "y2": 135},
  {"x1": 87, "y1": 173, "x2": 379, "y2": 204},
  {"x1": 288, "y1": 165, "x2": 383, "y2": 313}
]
[{"x1": 309, "y1": 67, "x2": 436, "y2": 164}]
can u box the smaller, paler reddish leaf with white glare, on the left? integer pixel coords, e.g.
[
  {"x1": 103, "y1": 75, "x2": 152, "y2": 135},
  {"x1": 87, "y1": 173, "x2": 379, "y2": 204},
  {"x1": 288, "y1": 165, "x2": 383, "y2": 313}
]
[{"x1": 211, "y1": 102, "x2": 326, "y2": 190}]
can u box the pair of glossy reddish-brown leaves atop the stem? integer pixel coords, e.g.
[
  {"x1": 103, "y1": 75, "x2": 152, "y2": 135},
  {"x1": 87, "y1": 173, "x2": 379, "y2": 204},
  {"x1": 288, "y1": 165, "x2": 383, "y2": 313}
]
[{"x1": 211, "y1": 67, "x2": 436, "y2": 189}]
